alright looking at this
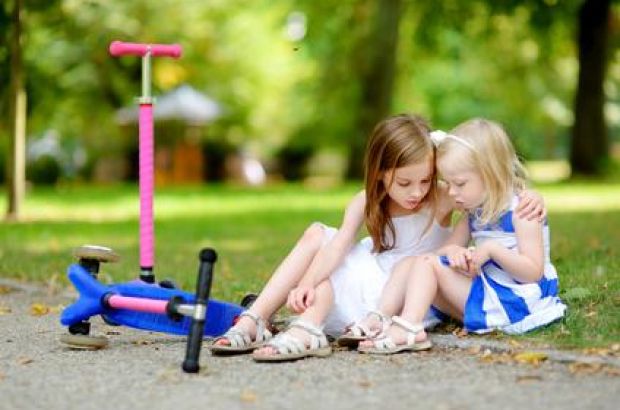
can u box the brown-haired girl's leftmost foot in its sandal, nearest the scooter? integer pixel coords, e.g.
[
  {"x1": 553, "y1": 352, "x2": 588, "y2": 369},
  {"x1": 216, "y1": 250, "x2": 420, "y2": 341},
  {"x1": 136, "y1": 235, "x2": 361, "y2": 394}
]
[{"x1": 211, "y1": 310, "x2": 273, "y2": 354}]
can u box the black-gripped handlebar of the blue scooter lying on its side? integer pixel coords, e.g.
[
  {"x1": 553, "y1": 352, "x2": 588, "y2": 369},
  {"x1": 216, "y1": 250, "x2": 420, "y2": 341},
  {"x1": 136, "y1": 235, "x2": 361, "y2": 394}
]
[{"x1": 182, "y1": 248, "x2": 217, "y2": 373}]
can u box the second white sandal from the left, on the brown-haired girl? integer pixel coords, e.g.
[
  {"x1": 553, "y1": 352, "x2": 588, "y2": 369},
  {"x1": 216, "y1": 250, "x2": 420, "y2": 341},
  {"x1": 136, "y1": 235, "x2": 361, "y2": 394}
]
[{"x1": 252, "y1": 319, "x2": 332, "y2": 362}]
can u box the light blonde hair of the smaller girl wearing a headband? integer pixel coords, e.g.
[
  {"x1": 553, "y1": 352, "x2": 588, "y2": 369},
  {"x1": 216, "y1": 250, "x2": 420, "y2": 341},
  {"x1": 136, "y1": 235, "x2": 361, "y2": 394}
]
[{"x1": 437, "y1": 118, "x2": 527, "y2": 224}]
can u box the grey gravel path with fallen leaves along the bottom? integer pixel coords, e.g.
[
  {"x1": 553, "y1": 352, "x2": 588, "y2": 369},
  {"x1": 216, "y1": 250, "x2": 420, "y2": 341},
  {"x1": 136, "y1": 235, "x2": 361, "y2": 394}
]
[{"x1": 0, "y1": 280, "x2": 620, "y2": 410}]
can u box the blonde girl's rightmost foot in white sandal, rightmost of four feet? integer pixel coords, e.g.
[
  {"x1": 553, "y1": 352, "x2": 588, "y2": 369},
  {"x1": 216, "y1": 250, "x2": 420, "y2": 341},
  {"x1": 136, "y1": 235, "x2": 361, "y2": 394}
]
[{"x1": 358, "y1": 316, "x2": 432, "y2": 354}]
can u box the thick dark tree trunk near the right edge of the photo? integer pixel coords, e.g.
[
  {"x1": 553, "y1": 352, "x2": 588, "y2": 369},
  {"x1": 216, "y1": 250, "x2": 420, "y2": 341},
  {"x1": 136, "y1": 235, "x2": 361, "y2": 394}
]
[{"x1": 570, "y1": 0, "x2": 610, "y2": 175}]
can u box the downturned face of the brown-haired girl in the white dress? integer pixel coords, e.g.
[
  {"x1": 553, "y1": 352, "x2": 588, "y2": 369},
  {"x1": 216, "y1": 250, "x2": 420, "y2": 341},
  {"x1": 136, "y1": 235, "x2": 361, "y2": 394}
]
[{"x1": 382, "y1": 156, "x2": 434, "y2": 213}]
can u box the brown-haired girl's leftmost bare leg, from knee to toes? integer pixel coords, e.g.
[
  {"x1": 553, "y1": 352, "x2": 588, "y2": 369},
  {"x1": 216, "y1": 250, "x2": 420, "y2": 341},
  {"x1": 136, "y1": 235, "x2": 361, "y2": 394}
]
[{"x1": 216, "y1": 223, "x2": 325, "y2": 345}]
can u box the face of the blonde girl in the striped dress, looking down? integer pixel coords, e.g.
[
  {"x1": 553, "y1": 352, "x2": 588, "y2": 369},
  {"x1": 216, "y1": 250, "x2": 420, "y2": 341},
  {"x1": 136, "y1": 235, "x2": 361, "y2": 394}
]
[{"x1": 437, "y1": 155, "x2": 486, "y2": 210}]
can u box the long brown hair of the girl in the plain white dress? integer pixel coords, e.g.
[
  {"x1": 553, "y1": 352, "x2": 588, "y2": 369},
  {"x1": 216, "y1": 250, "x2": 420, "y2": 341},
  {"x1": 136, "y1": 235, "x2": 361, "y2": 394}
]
[{"x1": 364, "y1": 114, "x2": 437, "y2": 252}]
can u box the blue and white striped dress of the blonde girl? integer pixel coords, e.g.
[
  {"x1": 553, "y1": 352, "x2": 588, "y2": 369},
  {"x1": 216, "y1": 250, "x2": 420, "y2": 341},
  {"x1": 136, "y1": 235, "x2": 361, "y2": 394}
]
[{"x1": 463, "y1": 196, "x2": 566, "y2": 334}]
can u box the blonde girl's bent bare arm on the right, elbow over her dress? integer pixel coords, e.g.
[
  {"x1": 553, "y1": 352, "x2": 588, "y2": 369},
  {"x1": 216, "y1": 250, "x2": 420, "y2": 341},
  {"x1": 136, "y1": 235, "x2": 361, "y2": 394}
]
[{"x1": 472, "y1": 216, "x2": 544, "y2": 283}]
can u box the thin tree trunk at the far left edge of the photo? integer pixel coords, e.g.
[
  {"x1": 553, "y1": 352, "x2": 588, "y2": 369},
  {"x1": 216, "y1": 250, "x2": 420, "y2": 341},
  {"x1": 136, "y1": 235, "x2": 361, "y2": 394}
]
[{"x1": 6, "y1": 0, "x2": 26, "y2": 220}]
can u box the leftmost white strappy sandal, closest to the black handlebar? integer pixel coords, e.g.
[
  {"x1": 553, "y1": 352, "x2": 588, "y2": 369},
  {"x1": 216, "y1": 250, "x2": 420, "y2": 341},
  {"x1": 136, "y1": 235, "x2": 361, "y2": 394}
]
[{"x1": 210, "y1": 310, "x2": 273, "y2": 354}]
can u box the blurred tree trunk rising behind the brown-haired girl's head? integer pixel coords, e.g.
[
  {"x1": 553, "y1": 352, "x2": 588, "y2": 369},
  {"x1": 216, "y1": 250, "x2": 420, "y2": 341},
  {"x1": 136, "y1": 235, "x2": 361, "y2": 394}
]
[{"x1": 347, "y1": 0, "x2": 402, "y2": 179}]
